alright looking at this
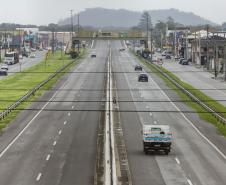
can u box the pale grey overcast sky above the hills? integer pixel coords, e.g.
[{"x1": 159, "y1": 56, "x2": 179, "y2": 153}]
[{"x1": 0, "y1": 0, "x2": 226, "y2": 25}]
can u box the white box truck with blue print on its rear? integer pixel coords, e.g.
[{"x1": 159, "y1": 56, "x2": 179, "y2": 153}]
[{"x1": 142, "y1": 125, "x2": 172, "y2": 155}]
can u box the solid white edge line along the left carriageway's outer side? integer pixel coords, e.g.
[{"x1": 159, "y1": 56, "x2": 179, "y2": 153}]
[{"x1": 0, "y1": 91, "x2": 58, "y2": 158}]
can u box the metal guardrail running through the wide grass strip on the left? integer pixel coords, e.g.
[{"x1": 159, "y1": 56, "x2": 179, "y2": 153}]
[{"x1": 0, "y1": 58, "x2": 74, "y2": 121}]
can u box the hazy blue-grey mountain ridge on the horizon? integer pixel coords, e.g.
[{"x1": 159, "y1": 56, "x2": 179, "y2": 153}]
[{"x1": 58, "y1": 7, "x2": 217, "y2": 28}]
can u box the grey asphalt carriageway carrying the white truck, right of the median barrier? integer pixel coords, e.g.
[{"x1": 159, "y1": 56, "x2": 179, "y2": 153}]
[{"x1": 112, "y1": 42, "x2": 226, "y2": 185}]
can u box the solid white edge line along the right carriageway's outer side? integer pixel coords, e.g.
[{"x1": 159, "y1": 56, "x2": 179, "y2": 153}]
[{"x1": 147, "y1": 66, "x2": 226, "y2": 160}]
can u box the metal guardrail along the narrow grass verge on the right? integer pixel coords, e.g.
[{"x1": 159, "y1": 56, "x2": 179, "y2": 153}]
[{"x1": 146, "y1": 61, "x2": 226, "y2": 125}]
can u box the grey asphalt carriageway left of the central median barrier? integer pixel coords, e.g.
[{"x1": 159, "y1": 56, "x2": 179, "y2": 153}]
[{"x1": 0, "y1": 41, "x2": 108, "y2": 185}]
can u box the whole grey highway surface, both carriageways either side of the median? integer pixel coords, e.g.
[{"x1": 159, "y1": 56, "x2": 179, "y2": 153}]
[{"x1": 0, "y1": 41, "x2": 226, "y2": 185}]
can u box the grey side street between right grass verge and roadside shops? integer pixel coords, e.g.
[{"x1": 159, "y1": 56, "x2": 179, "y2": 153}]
[{"x1": 163, "y1": 57, "x2": 226, "y2": 106}]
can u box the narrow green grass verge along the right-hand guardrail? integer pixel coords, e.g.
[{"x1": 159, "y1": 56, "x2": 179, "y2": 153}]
[{"x1": 132, "y1": 51, "x2": 226, "y2": 137}]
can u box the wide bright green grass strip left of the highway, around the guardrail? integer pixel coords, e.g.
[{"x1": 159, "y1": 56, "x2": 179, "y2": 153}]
[{"x1": 0, "y1": 50, "x2": 85, "y2": 130}]
